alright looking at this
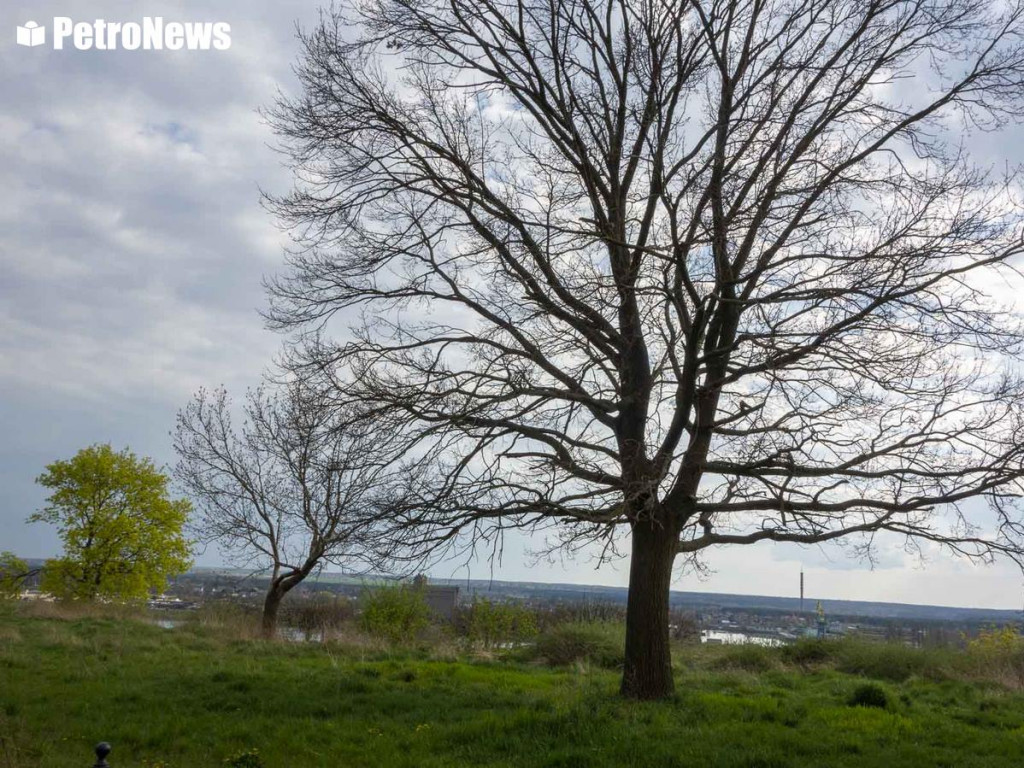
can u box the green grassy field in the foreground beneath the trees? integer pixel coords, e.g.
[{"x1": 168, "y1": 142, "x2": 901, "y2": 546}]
[{"x1": 0, "y1": 606, "x2": 1024, "y2": 768}]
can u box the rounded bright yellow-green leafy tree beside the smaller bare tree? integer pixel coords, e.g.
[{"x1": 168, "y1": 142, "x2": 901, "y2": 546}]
[{"x1": 29, "y1": 444, "x2": 191, "y2": 599}]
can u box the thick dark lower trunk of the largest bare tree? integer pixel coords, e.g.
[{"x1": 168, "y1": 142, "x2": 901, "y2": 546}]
[{"x1": 622, "y1": 520, "x2": 676, "y2": 699}]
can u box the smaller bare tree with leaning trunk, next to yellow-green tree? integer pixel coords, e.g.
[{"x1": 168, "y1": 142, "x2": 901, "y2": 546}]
[{"x1": 174, "y1": 384, "x2": 408, "y2": 636}]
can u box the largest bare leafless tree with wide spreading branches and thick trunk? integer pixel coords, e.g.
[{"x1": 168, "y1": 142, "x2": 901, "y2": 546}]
[{"x1": 270, "y1": 0, "x2": 1024, "y2": 697}]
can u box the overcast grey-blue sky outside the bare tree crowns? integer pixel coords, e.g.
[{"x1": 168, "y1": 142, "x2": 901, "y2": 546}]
[{"x1": 0, "y1": 0, "x2": 1024, "y2": 607}]
